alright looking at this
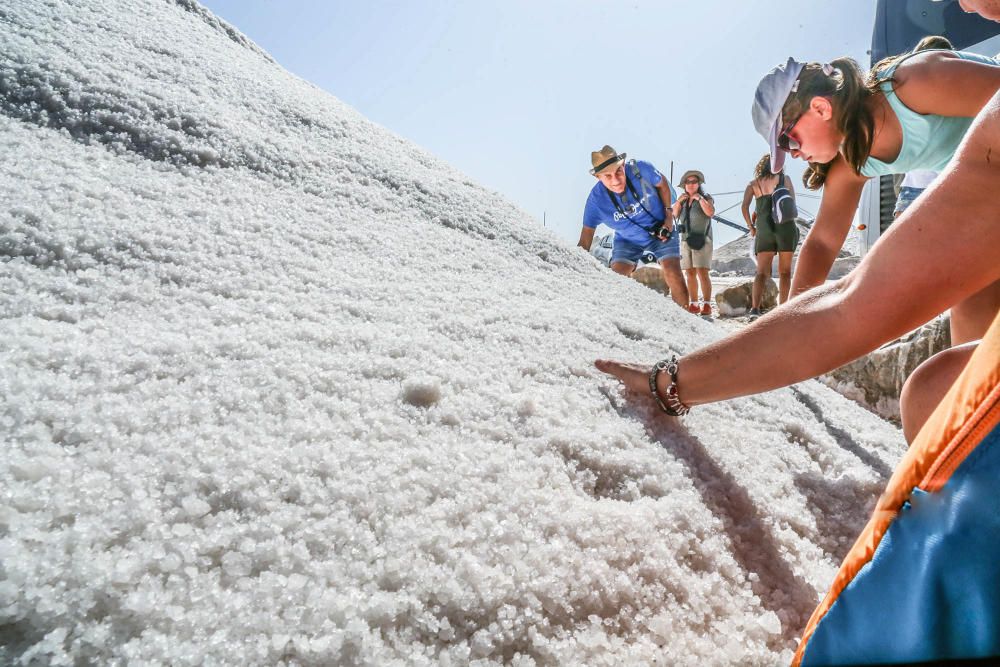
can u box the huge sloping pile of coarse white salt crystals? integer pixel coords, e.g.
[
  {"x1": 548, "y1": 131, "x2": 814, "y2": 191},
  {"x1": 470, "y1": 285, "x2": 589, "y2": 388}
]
[{"x1": 0, "y1": 0, "x2": 902, "y2": 665}]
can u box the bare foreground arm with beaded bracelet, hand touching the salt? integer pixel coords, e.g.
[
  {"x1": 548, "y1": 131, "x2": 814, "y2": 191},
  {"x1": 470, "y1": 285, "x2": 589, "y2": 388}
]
[{"x1": 597, "y1": 94, "x2": 1000, "y2": 405}]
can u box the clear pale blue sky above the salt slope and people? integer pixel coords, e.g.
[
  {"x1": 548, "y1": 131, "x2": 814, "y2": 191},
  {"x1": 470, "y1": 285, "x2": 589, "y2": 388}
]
[{"x1": 201, "y1": 0, "x2": 875, "y2": 242}]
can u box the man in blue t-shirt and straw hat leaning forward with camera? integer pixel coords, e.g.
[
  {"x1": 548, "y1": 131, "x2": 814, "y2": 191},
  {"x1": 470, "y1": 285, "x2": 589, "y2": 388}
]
[{"x1": 578, "y1": 146, "x2": 688, "y2": 309}]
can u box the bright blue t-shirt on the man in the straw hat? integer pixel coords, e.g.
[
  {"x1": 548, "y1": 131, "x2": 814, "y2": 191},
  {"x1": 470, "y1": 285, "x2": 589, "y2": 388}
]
[{"x1": 583, "y1": 160, "x2": 677, "y2": 246}]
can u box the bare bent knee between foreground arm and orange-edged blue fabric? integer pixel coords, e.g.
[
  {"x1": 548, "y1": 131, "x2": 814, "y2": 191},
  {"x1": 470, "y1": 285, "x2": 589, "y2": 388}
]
[{"x1": 899, "y1": 341, "x2": 979, "y2": 443}]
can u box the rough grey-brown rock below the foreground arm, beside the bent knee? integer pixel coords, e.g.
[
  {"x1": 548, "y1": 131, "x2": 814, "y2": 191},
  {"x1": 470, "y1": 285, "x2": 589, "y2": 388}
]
[{"x1": 819, "y1": 317, "x2": 951, "y2": 423}]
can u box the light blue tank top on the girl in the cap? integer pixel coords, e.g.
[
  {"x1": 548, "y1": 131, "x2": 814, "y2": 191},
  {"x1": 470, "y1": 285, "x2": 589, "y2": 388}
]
[{"x1": 861, "y1": 51, "x2": 998, "y2": 178}]
